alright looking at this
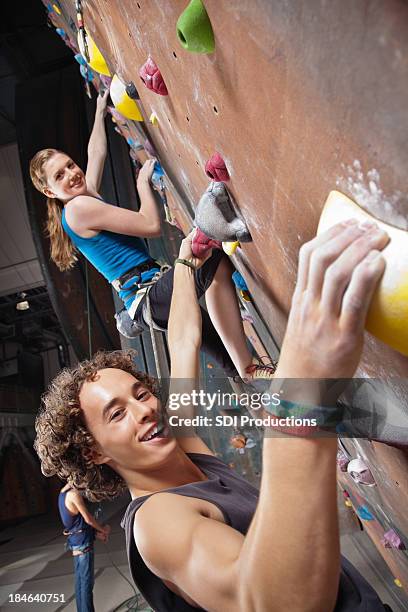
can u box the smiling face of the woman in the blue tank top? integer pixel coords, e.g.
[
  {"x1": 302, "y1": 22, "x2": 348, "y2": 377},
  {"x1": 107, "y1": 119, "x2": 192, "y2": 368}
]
[{"x1": 43, "y1": 153, "x2": 87, "y2": 202}]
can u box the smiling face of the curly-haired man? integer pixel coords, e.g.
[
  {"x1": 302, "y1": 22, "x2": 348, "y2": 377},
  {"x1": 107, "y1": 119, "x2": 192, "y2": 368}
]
[{"x1": 79, "y1": 368, "x2": 177, "y2": 480}]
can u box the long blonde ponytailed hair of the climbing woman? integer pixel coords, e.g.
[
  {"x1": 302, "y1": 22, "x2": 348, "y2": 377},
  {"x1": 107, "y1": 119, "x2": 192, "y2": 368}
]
[{"x1": 30, "y1": 149, "x2": 78, "y2": 271}]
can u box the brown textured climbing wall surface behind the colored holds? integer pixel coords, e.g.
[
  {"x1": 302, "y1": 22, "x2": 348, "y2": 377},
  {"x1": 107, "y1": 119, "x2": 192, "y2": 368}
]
[{"x1": 44, "y1": 0, "x2": 408, "y2": 589}]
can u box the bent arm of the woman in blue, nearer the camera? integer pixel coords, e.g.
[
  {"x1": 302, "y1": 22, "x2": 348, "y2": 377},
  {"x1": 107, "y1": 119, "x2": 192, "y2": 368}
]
[{"x1": 66, "y1": 159, "x2": 160, "y2": 238}]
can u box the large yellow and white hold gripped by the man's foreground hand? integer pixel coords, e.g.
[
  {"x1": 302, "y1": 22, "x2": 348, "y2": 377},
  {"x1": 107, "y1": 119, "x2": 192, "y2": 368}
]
[{"x1": 317, "y1": 191, "x2": 408, "y2": 355}]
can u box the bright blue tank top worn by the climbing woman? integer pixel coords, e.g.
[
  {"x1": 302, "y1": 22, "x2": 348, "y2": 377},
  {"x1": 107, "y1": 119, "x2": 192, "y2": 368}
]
[{"x1": 61, "y1": 209, "x2": 158, "y2": 308}]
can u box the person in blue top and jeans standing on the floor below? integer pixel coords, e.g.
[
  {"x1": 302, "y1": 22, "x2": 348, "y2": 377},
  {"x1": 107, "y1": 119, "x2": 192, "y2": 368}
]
[{"x1": 58, "y1": 484, "x2": 110, "y2": 612}]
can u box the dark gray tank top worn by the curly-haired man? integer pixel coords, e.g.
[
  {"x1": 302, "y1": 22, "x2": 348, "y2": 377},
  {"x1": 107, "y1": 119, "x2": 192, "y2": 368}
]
[{"x1": 121, "y1": 453, "x2": 384, "y2": 612}]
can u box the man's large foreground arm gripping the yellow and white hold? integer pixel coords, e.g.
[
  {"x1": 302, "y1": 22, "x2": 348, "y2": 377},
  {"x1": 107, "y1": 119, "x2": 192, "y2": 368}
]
[{"x1": 135, "y1": 224, "x2": 388, "y2": 612}]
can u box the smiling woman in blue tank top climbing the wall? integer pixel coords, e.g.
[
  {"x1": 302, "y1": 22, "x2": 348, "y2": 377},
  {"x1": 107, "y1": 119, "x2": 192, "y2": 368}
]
[{"x1": 30, "y1": 92, "x2": 275, "y2": 379}]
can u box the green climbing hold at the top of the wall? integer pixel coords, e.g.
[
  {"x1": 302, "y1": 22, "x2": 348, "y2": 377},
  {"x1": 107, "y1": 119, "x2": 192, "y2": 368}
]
[{"x1": 177, "y1": 0, "x2": 215, "y2": 53}]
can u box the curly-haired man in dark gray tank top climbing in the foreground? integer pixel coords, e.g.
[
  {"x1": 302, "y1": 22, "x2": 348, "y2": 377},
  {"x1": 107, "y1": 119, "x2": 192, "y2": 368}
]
[{"x1": 35, "y1": 221, "x2": 388, "y2": 612}]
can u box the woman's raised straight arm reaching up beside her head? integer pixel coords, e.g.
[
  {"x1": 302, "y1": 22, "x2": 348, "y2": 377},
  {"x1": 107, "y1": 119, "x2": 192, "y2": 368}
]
[{"x1": 85, "y1": 89, "x2": 109, "y2": 193}]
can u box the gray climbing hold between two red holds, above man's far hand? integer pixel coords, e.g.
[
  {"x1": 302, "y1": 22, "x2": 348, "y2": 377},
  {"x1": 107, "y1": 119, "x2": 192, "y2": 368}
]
[{"x1": 195, "y1": 181, "x2": 252, "y2": 242}]
